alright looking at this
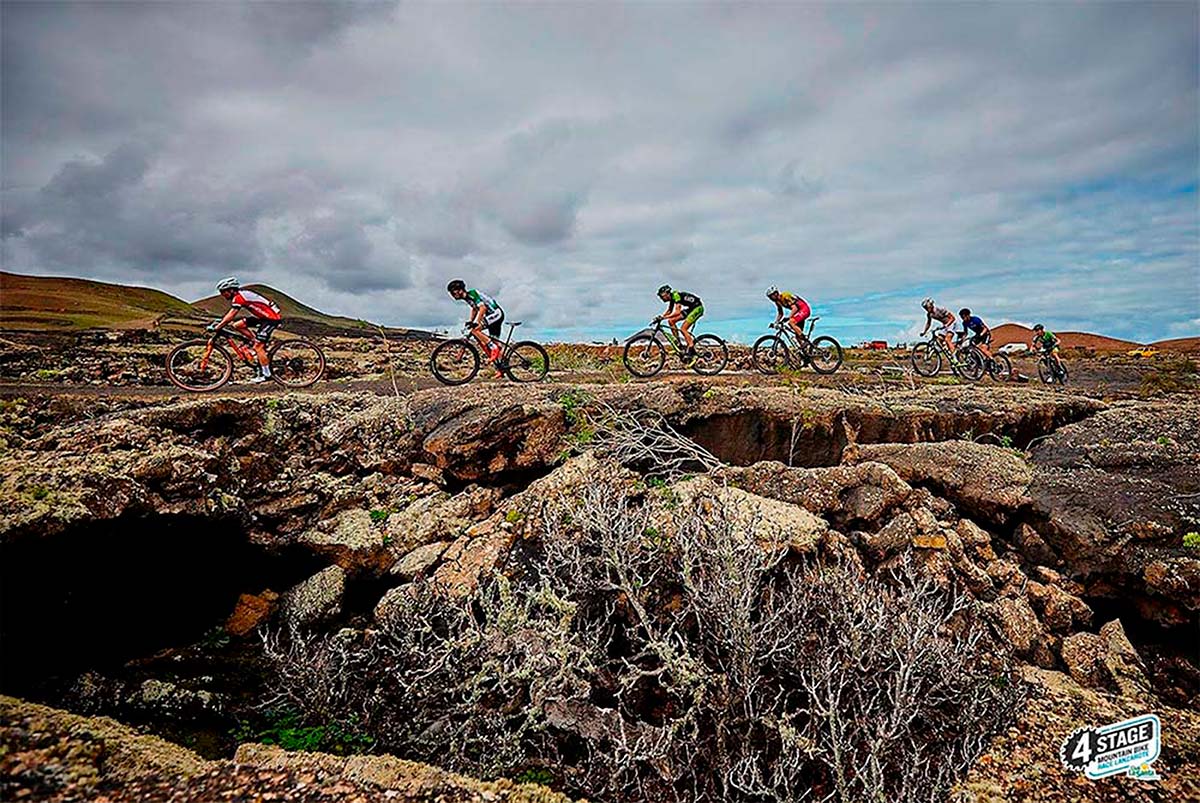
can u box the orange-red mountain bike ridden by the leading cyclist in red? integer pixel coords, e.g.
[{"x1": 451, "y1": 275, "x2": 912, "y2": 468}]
[{"x1": 167, "y1": 326, "x2": 325, "y2": 392}]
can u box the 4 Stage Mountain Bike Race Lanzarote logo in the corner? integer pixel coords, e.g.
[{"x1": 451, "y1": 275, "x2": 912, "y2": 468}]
[{"x1": 1058, "y1": 714, "x2": 1163, "y2": 780}]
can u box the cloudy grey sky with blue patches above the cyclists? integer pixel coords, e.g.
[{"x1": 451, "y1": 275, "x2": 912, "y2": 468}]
[{"x1": 0, "y1": 0, "x2": 1200, "y2": 341}]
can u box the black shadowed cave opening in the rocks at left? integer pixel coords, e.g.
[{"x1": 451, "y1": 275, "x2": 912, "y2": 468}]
[{"x1": 0, "y1": 515, "x2": 320, "y2": 697}]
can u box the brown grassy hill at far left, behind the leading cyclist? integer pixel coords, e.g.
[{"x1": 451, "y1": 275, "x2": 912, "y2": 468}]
[{"x1": 0, "y1": 271, "x2": 200, "y2": 330}]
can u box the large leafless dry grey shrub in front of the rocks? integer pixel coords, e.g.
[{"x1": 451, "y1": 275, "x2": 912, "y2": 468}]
[{"x1": 268, "y1": 490, "x2": 1024, "y2": 803}]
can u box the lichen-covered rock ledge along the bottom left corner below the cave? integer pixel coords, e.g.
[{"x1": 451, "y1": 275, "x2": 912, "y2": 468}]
[{"x1": 0, "y1": 696, "x2": 569, "y2": 803}]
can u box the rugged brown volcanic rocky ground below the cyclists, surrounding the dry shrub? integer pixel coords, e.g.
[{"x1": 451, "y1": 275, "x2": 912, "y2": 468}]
[{"x1": 0, "y1": 382, "x2": 1200, "y2": 801}]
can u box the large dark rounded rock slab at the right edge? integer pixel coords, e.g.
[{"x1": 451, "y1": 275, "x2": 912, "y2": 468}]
[{"x1": 1030, "y1": 403, "x2": 1200, "y2": 625}]
